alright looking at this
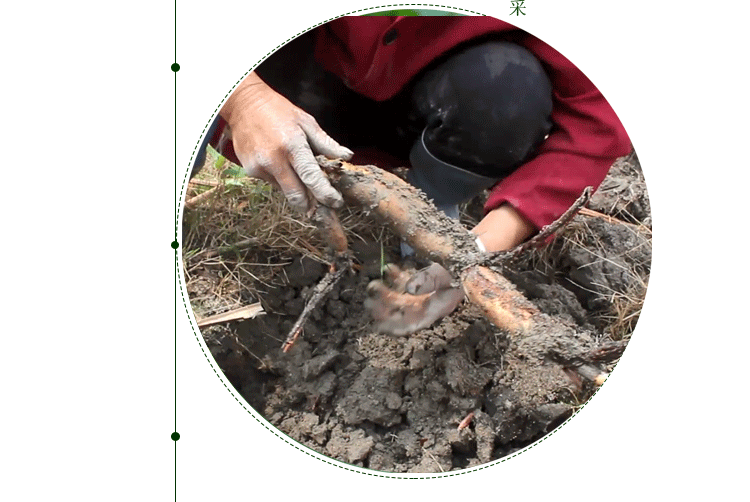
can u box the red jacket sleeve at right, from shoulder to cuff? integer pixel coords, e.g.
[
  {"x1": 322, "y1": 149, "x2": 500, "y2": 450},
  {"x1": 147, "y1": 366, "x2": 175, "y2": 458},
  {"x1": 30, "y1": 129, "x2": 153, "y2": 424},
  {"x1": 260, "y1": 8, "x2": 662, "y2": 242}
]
[{"x1": 485, "y1": 36, "x2": 631, "y2": 228}]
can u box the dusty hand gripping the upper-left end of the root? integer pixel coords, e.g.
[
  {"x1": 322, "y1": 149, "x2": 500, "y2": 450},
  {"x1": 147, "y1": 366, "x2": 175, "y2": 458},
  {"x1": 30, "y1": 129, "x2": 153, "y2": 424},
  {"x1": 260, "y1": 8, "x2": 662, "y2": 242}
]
[{"x1": 221, "y1": 73, "x2": 353, "y2": 211}]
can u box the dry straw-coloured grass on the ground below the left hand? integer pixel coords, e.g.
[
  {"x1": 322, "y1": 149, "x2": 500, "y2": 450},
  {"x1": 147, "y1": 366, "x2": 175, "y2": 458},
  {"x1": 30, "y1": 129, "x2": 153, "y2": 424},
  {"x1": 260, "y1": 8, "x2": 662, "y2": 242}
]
[{"x1": 183, "y1": 148, "x2": 393, "y2": 317}]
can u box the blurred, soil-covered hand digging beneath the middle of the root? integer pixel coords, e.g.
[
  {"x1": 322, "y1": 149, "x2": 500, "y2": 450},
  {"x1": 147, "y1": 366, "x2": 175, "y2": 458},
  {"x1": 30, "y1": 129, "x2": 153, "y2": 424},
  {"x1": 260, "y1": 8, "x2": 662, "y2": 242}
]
[{"x1": 365, "y1": 263, "x2": 464, "y2": 335}]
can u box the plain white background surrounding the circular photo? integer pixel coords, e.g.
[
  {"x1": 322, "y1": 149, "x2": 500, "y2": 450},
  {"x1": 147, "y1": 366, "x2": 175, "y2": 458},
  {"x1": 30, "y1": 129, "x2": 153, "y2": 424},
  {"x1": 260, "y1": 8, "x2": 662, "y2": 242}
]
[{"x1": 0, "y1": 0, "x2": 750, "y2": 501}]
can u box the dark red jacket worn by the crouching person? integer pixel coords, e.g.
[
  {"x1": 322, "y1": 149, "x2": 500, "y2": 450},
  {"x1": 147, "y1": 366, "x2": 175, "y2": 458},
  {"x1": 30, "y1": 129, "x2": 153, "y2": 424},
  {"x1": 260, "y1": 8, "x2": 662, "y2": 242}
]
[{"x1": 316, "y1": 16, "x2": 631, "y2": 228}]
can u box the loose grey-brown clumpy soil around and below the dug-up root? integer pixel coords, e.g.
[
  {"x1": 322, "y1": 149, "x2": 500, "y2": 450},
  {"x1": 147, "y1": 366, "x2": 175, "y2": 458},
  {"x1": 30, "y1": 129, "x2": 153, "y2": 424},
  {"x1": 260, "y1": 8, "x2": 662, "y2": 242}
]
[{"x1": 188, "y1": 151, "x2": 651, "y2": 473}]
